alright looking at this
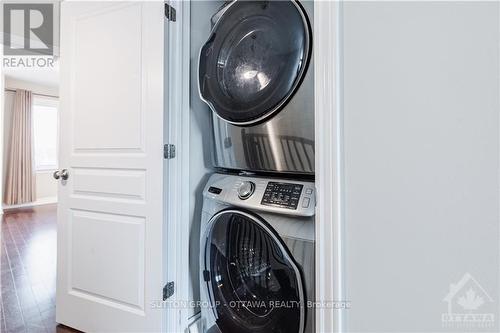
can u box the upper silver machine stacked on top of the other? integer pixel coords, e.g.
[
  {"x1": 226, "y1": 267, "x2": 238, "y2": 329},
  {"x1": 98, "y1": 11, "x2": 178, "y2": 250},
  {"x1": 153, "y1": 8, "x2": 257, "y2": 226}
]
[{"x1": 198, "y1": 0, "x2": 314, "y2": 175}]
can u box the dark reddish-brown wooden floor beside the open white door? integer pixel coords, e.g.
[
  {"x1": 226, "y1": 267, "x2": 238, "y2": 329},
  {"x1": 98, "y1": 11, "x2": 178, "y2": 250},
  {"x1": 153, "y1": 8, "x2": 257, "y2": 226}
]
[{"x1": 0, "y1": 205, "x2": 76, "y2": 333}]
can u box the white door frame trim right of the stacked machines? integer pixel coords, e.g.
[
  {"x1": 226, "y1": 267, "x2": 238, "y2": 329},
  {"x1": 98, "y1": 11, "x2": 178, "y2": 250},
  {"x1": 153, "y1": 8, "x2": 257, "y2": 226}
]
[{"x1": 313, "y1": 1, "x2": 346, "y2": 332}]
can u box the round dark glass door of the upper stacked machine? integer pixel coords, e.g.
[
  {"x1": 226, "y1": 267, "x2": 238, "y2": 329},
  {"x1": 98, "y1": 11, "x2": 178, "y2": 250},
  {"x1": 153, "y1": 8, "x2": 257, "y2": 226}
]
[{"x1": 198, "y1": 1, "x2": 311, "y2": 126}]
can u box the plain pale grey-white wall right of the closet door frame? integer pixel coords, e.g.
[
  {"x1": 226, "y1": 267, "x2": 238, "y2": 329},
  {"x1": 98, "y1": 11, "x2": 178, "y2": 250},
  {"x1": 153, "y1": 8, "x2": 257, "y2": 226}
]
[{"x1": 343, "y1": 2, "x2": 500, "y2": 332}]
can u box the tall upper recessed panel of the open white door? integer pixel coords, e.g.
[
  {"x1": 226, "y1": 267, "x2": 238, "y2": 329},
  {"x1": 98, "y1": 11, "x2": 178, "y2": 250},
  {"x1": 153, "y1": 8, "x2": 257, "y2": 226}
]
[{"x1": 71, "y1": 3, "x2": 144, "y2": 153}]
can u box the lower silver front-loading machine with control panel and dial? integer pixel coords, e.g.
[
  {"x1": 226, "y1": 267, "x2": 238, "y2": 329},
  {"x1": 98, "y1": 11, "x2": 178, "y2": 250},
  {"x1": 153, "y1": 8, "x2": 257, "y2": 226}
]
[{"x1": 200, "y1": 174, "x2": 315, "y2": 333}]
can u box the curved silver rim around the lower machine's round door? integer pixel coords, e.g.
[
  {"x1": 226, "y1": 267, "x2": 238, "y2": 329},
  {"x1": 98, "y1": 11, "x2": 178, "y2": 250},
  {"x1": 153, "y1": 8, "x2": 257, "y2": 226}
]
[{"x1": 202, "y1": 209, "x2": 307, "y2": 333}]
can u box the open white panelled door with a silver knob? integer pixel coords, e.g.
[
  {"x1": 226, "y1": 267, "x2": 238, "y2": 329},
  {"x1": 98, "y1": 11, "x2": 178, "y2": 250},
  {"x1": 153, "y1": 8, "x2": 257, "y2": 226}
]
[{"x1": 57, "y1": 2, "x2": 164, "y2": 332}]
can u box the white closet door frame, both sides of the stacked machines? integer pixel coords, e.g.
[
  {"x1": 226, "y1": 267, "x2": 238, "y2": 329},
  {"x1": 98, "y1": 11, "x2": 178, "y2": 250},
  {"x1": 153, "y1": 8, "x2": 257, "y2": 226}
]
[{"x1": 165, "y1": 0, "x2": 346, "y2": 332}]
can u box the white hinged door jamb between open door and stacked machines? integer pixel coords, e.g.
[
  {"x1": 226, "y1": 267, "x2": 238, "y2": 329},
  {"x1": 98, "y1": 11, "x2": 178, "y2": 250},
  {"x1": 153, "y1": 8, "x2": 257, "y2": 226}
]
[{"x1": 164, "y1": 0, "x2": 190, "y2": 332}]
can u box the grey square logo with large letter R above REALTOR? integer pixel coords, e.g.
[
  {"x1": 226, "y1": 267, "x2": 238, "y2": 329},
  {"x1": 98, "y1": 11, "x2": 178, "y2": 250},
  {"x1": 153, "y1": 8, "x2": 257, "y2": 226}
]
[{"x1": 3, "y1": 3, "x2": 54, "y2": 56}]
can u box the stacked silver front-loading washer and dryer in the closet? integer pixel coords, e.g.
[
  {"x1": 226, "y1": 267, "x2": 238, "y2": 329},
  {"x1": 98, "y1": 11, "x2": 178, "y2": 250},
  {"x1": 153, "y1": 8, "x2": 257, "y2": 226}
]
[{"x1": 198, "y1": 0, "x2": 315, "y2": 333}]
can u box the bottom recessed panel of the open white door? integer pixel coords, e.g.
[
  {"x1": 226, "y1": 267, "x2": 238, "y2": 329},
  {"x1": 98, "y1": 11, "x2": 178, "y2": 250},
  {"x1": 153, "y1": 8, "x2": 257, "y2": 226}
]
[{"x1": 68, "y1": 210, "x2": 145, "y2": 310}]
